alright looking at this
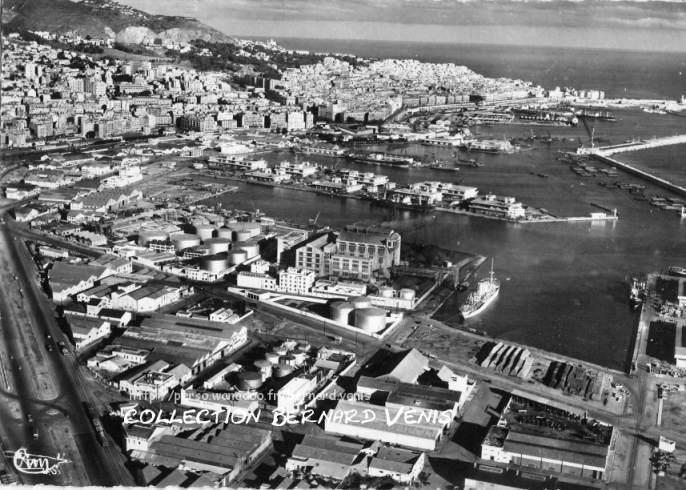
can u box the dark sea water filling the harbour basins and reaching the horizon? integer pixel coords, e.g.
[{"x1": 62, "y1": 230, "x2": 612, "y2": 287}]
[{"x1": 208, "y1": 39, "x2": 686, "y2": 369}]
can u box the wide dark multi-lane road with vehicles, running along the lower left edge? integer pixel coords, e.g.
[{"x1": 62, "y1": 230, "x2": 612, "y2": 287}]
[{"x1": 0, "y1": 224, "x2": 132, "y2": 486}]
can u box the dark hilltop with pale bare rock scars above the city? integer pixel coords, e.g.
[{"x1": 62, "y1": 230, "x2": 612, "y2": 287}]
[{"x1": 2, "y1": 0, "x2": 235, "y2": 44}]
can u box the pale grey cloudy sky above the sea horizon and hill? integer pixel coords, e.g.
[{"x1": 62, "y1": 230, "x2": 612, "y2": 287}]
[{"x1": 119, "y1": 0, "x2": 686, "y2": 52}]
